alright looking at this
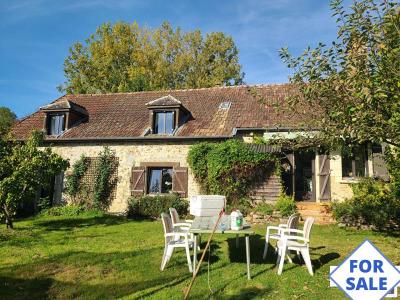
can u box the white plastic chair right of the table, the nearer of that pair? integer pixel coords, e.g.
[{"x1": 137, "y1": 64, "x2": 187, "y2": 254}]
[{"x1": 277, "y1": 218, "x2": 314, "y2": 276}]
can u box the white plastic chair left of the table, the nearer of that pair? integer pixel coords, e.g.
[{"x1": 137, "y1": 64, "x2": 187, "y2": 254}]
[{"x1": 161, "y1": 213, "x2": 193, "y2": 273}]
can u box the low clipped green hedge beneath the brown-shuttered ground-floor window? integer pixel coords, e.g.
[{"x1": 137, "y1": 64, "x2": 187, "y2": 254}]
[{"x1": 128, "y1": 194, "x2": 189, "y2": 218}]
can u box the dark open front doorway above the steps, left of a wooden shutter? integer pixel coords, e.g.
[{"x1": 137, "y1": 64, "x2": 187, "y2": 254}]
[{"x1": 294, "y1": 150, "x2": 316, "y2": 201}]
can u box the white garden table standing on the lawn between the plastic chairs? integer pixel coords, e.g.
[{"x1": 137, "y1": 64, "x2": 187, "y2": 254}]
[{"x1": 189, "y1": 215, "x2": 254, "y2": 280}]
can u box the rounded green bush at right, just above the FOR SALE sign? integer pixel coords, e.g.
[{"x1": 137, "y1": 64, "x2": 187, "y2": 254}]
[{"x1": 332, "y1": 178, "x2": 400, "y2": 229}]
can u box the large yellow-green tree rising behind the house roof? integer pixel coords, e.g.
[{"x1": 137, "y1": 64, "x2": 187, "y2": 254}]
[{"x1": 59, "y1": 22, "x2": 243, "y2": 93}]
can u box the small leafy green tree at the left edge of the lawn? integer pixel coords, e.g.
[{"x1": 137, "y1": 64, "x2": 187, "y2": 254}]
[{"x1": 0, "y1": 133, "x2": 69, "y2": 228}]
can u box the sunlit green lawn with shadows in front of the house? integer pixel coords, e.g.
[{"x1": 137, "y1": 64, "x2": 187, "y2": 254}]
[{"x1": 0, "y1": 213, "x2": 400, "y2": 299}]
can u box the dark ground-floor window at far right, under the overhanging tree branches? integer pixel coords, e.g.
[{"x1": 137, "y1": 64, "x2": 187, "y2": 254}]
[{"x1": 342, "y1": 146, "x2": 368, "y2": 178}]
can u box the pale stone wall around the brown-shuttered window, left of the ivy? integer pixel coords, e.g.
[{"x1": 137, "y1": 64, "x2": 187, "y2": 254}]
[{"x1": 48, "y1": 142, "x2": 200, "y2": 213}]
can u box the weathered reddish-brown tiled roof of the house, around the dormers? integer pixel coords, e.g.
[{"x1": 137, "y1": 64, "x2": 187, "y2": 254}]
[{"x1": 13, "y1": 84, "x2": 310, "y2": 140}]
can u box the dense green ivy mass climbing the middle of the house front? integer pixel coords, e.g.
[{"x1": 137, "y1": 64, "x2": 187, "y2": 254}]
[{"x1": 188, "y1": 140, "x2": 279, "y2": 205}]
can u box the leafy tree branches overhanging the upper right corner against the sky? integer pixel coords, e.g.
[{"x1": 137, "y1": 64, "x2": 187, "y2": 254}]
[{"x1": 280, "y1": 0, "x2": 400, "y2": 146}]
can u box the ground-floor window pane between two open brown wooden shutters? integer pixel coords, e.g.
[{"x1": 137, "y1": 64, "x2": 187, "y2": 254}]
[{"x1": 147, "y1": 168, "x2": 173, "y2": 194}]
